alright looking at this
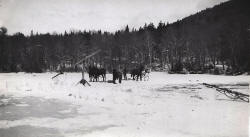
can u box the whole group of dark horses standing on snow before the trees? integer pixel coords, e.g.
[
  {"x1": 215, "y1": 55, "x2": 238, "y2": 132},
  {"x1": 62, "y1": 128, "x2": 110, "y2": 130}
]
[{"x1": 88, "y1": 66, "x2": 149, "y2": 83}]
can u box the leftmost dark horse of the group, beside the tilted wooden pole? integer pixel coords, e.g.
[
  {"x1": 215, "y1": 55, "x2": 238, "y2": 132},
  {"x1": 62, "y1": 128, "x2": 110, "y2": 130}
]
[{"x1": 88, "y1": 66, "x2": 106, "y2": 82}]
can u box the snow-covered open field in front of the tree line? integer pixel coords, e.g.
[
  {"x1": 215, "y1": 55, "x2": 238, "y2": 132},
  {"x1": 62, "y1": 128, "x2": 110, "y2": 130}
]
[{"x1": 0, "y1": 72, "x2": 250, "y2": 137}]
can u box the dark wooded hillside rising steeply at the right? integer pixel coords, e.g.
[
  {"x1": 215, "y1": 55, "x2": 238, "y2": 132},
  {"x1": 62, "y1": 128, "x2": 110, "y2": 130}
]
[{"x1": 166, "y1": 0, "x2": 250, "y2": 73}]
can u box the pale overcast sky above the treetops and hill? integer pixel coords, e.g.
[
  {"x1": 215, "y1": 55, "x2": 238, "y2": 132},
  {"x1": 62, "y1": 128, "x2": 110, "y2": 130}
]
[{"x1": 0, "y1": 0, "x2": 227, "y2": 34}]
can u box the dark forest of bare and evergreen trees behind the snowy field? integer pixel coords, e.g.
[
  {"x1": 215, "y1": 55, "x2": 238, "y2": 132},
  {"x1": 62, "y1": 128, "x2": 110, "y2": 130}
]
[{"x1": 0, "y1": 0, "x2": 250, "y2": 75}]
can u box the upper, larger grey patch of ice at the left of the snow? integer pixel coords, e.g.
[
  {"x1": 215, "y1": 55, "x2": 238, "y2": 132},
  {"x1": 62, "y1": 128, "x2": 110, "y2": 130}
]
[{"x1": 0, "y1": 96, "x2": 77, "y2": 120}]
